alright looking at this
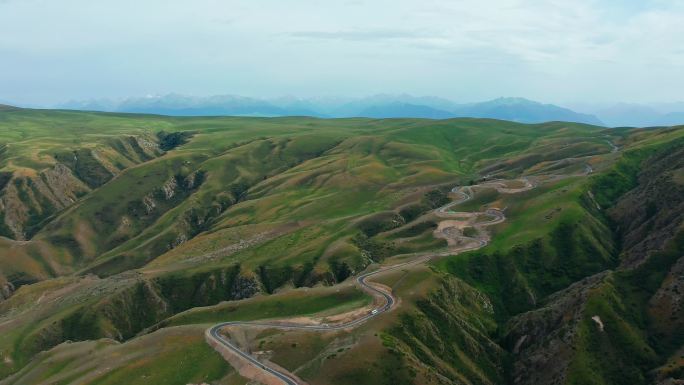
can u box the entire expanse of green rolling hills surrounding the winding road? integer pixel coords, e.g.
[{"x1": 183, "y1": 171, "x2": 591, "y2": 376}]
[{"x1": 0, "y1": 105, "x2": 684, "y2": 384}]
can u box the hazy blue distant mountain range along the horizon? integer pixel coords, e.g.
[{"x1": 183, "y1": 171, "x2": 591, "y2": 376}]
[{"x1": 58, "y1": 94, "x2": 603, "y2": 125}]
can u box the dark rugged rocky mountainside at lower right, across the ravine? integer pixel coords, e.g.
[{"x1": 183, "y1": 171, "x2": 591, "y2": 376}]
[{"x1": 505, "y1": 146, "x2": 684, "y2": 385}]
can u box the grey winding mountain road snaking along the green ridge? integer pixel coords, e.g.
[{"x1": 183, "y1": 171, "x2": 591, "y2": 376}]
[{"x1": 206, "y1": 178, "x2": 535, "y2": 385}]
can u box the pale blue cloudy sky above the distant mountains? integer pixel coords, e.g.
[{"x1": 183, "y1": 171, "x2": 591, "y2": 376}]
[{"x1": 0, "y1": 0, "x2": 684, "y2": 106}]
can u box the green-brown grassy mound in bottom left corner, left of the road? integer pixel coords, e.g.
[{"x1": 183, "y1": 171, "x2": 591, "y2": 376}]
[{"x1": 4, "y1": 326, "x2": 240, "y2": 385}]
